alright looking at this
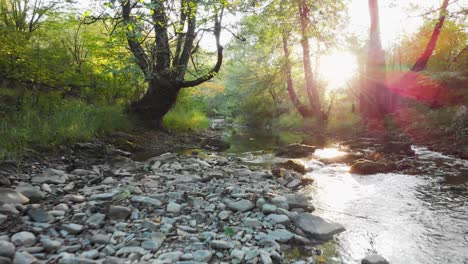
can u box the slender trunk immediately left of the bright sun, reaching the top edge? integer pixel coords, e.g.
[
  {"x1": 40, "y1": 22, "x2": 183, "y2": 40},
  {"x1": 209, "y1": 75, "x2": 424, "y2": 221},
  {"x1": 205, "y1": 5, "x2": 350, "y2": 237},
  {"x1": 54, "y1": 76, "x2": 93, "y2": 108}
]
[{"x1": 298, "y1": 0, "x2": 325, "y2": 121}]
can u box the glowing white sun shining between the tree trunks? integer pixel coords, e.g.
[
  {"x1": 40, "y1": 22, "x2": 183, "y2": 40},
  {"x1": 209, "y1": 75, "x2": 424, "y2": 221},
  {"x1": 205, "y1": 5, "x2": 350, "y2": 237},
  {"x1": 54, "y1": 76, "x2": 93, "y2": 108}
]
[{"x1": 319, "y1": 52, "x2": 358, "y2": 90}]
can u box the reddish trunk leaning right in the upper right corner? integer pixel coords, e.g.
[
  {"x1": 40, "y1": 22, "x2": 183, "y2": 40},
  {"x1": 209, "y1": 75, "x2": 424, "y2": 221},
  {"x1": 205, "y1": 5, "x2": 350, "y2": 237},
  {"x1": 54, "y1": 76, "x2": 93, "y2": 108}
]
[{"x1": 411, "y1": 0, "x2": 449, "y2": 72}]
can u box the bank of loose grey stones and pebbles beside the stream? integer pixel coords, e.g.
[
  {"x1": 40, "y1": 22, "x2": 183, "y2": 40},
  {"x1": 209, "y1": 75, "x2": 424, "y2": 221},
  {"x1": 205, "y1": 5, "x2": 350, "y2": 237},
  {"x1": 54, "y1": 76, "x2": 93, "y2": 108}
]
[{"x1": 0, "y1": 142, "x2": 345, "y2": 264}]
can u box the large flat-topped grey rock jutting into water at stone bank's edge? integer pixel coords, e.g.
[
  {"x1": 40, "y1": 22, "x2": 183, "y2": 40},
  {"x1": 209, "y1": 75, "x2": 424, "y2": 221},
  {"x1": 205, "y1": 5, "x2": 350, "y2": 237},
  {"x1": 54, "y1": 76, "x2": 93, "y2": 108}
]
[{"x1": 292, "y1": 213, "x2": 345, "y2": 240}]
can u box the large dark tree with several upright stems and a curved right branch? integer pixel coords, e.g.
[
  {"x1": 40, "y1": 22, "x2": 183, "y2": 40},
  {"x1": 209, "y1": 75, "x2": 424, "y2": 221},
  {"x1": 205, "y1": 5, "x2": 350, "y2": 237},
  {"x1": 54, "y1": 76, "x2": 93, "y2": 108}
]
[{"x1": 110, "y1": 0, "x2": 226, "y2": 128}]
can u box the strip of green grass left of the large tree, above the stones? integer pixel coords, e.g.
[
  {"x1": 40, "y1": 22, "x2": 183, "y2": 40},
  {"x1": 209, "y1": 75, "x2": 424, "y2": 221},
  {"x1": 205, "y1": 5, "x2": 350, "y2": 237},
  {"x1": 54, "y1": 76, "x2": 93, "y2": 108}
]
[{"x1": 0, "y1": 100, "x2": 130, "y2": 160}]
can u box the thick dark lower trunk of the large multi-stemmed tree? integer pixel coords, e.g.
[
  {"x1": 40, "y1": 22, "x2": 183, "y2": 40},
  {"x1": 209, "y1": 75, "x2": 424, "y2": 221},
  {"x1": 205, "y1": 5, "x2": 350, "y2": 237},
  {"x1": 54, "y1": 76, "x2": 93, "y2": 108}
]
[{"x1": 130, "y1": 78, "x2": 182, "y2": 129}]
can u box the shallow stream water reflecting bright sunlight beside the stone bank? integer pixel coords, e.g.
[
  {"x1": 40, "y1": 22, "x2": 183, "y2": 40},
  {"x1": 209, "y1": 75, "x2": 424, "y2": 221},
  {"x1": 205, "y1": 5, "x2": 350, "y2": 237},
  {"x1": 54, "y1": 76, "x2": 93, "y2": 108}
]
[{"x1": 222, "y1": 127, "x2": 468, "y2": 264}]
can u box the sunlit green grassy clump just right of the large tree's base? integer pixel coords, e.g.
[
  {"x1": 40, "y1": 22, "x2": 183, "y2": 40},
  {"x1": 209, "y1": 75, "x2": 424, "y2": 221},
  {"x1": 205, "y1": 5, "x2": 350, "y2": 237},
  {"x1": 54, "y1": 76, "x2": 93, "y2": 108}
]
[{"x1": 163, "y1": 90, "x2": 210, "y2": 130}]
